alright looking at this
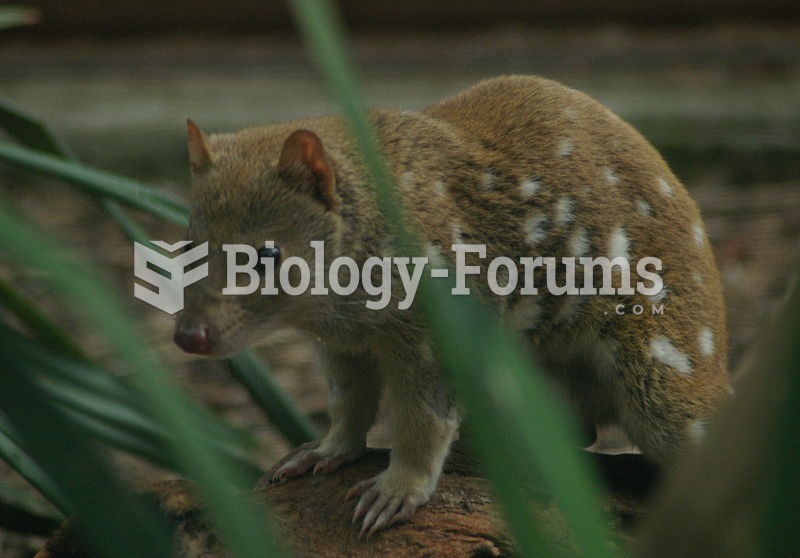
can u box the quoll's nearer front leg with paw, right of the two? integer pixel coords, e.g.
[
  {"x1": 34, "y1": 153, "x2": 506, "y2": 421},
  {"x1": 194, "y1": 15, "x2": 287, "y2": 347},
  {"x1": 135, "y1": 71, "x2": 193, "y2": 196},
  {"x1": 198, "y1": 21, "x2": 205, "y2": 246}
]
[{"x1": 347, "y1": 351, "x2": 458, "y2": 535}]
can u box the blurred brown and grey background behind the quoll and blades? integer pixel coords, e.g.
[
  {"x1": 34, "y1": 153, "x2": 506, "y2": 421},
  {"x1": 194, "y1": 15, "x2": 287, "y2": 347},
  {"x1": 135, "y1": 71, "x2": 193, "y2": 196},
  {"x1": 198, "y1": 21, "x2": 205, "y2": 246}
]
[{"x1": 0, "y1": 0, "x2": 800, "y2": 557}]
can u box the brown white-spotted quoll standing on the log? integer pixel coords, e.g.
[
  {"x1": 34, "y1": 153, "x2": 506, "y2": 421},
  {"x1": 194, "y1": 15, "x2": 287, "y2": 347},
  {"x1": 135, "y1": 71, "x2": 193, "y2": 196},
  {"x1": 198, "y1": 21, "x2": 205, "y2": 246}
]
[{"x1": 178, "y1": 76, "x2": 728, "y2": 531}]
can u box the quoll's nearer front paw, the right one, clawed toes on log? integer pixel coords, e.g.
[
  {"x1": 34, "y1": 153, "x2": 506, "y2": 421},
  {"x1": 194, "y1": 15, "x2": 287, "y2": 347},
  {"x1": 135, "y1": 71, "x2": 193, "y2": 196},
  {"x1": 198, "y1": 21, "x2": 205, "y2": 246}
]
[{"x1": 346, "y1": 471, "x2": 433, "y2": 536}]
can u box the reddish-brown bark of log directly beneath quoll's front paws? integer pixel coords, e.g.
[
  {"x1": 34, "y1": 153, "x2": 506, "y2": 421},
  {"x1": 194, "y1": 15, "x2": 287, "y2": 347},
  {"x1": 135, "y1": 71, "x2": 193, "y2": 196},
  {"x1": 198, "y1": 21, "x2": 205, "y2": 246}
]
[{"x1": 256, "y1": 450, "x2": 512, "y2": 557}]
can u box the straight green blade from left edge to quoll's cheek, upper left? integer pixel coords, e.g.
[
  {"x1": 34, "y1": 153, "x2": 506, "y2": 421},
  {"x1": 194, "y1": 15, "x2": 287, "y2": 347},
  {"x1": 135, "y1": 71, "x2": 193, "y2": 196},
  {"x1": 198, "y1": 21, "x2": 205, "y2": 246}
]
[{"x1": 0, "y1": 142, "x2": 188, "y2": 226}]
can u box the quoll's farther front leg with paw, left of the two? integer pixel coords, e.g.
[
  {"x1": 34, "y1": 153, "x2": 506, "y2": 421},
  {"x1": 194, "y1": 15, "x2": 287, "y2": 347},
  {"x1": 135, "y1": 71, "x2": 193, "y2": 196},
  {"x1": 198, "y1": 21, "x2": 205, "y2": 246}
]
[{"x1": 273, "y1": 353, "x2": 381, "y2": 482}]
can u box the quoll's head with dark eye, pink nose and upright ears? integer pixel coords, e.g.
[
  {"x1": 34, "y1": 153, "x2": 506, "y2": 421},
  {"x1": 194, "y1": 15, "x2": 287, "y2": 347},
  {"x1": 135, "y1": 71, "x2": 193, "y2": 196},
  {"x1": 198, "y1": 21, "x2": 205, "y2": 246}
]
[{"x1": 174, "y1": 121, "x2": 340, "y2": 357}]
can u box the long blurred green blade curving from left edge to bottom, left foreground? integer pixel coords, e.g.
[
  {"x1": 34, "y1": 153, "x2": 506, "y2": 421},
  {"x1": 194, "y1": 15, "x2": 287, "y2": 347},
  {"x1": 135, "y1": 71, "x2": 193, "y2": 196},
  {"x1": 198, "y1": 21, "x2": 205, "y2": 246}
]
[{"x1": 0, "y1": 195, "x2": 281, "y2": 557}]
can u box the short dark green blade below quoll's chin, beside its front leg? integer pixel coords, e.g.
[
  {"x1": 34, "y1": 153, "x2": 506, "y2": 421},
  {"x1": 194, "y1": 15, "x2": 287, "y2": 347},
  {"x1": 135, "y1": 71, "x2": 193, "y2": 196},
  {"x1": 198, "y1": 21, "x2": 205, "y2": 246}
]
[{"x1": 225, "y1": 352, "x2": 319, "y2": 446}]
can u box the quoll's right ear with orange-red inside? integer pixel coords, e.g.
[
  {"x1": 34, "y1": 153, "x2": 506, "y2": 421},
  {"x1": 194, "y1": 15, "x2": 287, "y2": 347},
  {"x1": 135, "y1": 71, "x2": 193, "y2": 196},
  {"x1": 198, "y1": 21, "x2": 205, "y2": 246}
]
[{"x1": 278, "y1": 130, "x2": 340, "y2": 211}]
